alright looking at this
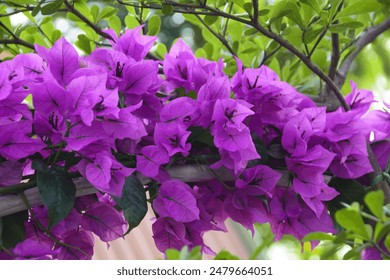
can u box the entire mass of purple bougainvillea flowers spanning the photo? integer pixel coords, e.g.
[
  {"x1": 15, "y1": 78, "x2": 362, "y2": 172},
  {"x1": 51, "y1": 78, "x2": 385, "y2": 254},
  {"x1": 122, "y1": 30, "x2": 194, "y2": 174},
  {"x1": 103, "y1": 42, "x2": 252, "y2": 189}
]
[{"x1": 0, "y1": 28, "x2": 390, "y2": 259}]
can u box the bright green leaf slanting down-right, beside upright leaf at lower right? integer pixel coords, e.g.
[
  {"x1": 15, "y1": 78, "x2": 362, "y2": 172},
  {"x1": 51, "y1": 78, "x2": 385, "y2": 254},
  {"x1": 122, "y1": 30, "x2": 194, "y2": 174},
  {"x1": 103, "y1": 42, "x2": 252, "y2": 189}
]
[{"x1": 336, "y1": 208, "x2": 370, "y2": 240}]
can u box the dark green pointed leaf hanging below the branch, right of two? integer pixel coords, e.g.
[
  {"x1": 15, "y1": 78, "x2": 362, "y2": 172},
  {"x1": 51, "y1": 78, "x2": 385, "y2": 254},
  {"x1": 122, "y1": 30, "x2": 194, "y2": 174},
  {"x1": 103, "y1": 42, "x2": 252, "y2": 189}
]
[{"x1": 113, "y1": 175, "x2": 148, "y2": 233}]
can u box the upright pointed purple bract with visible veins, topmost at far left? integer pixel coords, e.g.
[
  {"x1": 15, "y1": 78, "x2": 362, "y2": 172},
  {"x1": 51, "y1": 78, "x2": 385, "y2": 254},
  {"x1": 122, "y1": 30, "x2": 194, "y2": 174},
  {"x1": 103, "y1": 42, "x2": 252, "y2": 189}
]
[{"x1": 35, "y1": 37, "x2": 80, "y2": 86}]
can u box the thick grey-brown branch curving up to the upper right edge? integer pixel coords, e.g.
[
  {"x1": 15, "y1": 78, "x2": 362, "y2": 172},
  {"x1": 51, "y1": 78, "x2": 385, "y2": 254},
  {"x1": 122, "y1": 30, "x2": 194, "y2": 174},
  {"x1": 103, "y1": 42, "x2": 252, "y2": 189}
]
[{"x1": 335, "y1": 17, "x2": 390, "y2": 87}]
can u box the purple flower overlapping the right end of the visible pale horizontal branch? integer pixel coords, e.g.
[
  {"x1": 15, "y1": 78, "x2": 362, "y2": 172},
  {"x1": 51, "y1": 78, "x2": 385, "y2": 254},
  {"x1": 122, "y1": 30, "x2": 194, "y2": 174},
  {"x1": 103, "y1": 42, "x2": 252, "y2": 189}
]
[{"x1": 236, "y1": 165, "x2": 282, "y2": 197}]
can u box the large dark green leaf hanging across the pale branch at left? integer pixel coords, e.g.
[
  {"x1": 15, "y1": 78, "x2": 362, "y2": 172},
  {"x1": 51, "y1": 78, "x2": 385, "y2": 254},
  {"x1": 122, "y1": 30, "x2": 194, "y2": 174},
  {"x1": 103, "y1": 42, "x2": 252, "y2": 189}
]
[{"x1": 36, "y1": 165, "x2": 76, "y2": 229}]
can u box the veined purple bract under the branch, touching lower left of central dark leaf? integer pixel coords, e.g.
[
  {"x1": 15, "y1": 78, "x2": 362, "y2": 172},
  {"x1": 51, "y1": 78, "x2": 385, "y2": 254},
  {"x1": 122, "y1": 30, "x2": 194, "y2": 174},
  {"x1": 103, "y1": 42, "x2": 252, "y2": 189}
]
[{"x1": 81, "y1": 203, "x2": 128, "y2": 242}]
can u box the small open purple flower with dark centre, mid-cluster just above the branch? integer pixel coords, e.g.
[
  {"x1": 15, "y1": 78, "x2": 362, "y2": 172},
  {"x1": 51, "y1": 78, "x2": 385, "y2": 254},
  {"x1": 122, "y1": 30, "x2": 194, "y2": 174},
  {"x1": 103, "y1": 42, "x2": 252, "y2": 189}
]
[{"x1": 154, "y1": 122, "x2": 191, "y2": 156}]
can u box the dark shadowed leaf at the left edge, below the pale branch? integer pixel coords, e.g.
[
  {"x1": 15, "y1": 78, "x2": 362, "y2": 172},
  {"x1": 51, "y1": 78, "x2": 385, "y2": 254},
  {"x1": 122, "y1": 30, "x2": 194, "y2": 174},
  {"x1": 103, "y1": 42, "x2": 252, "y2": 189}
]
[{"x1": 0, "y1": 211, "x2": 28, "y2": 248}]
